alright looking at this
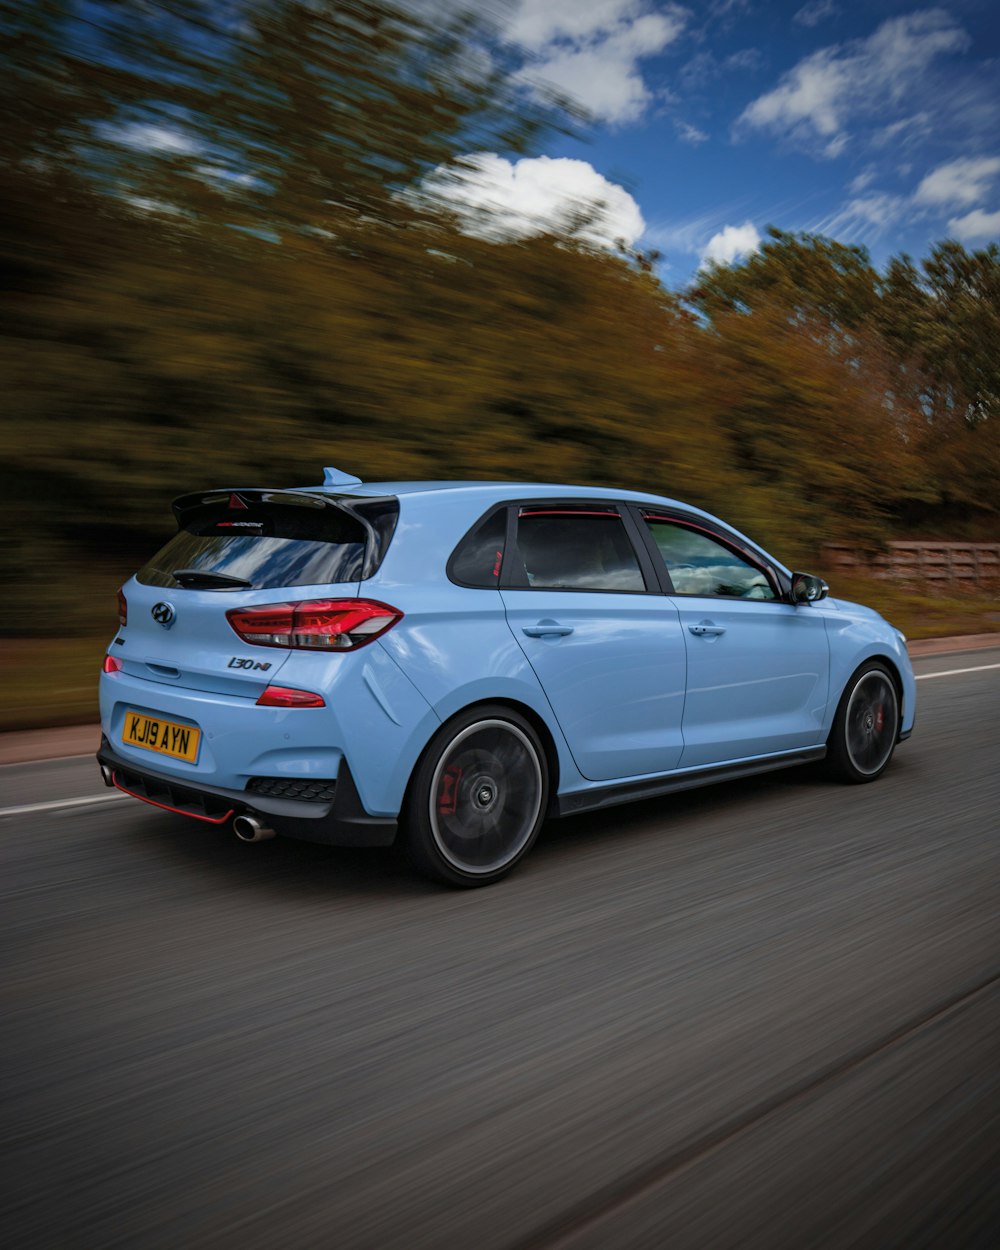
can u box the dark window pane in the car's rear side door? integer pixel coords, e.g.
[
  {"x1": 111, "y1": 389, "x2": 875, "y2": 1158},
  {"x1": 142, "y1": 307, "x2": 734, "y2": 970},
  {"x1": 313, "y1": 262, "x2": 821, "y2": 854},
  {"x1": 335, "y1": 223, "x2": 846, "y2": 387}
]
[{"x1": 511, "y1": 506, "x2": 646, "y2": 594}]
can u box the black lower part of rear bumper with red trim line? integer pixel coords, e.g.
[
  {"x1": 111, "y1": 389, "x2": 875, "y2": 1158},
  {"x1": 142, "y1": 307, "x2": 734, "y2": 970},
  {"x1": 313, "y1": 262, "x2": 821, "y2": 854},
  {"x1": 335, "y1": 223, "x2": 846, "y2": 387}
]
[{"x1": 98, "y1": 738, "x2": 398, "y2": 846}]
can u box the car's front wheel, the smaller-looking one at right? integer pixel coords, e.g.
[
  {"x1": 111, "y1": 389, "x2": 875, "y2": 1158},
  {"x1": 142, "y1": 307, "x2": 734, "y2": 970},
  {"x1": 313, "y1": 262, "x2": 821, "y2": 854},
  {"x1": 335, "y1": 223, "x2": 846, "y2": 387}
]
[{"x1": 826, "y1": 660, "x2": 900, "y2": 785}]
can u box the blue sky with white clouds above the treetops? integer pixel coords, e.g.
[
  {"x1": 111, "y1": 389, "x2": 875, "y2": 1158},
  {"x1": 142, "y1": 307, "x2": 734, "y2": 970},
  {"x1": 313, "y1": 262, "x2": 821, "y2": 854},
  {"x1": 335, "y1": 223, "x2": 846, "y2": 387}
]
[{"x1": 427, "y1": 0, "x2": 1000, "y2": 284}]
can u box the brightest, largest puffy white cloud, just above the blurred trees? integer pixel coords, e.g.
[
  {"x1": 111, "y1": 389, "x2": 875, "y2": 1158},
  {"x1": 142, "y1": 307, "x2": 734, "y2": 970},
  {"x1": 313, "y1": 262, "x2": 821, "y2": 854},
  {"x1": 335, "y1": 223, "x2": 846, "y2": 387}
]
[{"x1": 423, "y1": 153, "x2": 645, "y2": 249}]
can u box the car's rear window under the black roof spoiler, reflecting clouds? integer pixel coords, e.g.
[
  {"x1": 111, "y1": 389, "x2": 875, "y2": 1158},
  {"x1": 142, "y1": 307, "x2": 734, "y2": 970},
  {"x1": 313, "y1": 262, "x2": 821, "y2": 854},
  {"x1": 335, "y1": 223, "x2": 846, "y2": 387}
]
[{"x1": 136, "y1": 496, "x2": 399, "y2": 590}]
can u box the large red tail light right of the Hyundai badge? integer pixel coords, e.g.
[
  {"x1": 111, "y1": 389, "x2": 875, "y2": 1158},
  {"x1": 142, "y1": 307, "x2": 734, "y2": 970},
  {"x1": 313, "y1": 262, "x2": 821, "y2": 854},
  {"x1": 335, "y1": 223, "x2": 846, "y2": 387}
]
[{"x1": 226, "y1": 599, "x2": 403, "y2": 651}]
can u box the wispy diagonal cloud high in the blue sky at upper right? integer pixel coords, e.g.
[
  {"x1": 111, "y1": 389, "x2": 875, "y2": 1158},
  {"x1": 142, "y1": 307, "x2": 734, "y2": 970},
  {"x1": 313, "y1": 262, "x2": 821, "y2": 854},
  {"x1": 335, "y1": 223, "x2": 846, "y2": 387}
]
[{"x1": 739, "y1": 9, "x2": 969, "y2": 154}]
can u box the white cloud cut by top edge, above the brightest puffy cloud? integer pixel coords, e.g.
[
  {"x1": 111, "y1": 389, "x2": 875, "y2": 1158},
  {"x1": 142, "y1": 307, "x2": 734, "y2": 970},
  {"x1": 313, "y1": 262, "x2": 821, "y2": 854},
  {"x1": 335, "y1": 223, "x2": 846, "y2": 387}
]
[{"x1": 508, "y1": 0, "x2": 689, "y2": 125}]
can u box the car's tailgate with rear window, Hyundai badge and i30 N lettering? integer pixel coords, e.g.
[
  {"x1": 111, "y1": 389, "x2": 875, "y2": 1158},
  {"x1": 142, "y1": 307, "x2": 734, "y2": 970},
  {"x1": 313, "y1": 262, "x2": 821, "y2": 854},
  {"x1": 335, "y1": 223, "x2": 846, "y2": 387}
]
[{"x1": 113, "y1": 490, "x2": 387, "y2": 699}]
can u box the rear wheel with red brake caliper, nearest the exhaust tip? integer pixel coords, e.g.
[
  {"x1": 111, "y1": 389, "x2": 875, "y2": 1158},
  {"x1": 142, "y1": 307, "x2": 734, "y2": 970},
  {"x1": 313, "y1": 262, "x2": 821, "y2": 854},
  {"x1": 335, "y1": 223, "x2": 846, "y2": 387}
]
[{"x1": 404, "y1": 705, "x2": 549, "y2": 888}]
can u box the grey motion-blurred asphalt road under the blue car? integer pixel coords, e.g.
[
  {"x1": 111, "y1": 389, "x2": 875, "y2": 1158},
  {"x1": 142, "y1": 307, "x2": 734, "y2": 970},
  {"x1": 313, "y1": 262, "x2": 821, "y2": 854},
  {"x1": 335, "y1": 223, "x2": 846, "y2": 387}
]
[{"x1": 0, "y1": 650, "x2": 1000, "y2": 1250}]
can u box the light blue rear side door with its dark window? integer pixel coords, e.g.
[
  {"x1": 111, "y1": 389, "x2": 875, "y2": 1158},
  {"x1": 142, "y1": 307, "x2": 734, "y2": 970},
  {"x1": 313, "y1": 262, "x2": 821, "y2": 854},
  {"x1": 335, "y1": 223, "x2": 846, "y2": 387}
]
[{"x1": 501, "y1": 501, "x2": 685, "y2": 781}]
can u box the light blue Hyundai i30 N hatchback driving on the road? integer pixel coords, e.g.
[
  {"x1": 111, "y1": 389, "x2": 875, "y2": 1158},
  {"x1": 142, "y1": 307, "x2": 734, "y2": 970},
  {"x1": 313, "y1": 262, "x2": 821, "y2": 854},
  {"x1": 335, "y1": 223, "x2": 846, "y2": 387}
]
[{"x1": 98, "y1": 469, "x2": 916, "y2": 886}]
